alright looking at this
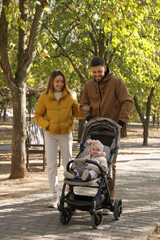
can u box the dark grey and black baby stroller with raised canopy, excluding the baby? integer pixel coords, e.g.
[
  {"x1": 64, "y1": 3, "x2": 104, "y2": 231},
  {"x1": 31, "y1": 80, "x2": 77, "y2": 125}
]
[{"x1": 58, "y1": 118, "x2": 122, "y2": 228}]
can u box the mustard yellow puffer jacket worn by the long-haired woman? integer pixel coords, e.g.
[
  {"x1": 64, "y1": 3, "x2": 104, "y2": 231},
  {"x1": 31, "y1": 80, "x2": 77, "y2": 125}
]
[{"x1": 35, "y1": 89, "x2": 83, "y2": 134}]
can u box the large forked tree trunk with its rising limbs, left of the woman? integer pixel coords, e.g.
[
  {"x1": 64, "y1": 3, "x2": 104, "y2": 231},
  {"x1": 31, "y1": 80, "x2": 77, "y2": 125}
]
[{"x1": 0, "y1": 0, "x2": 47, "y2": 178}]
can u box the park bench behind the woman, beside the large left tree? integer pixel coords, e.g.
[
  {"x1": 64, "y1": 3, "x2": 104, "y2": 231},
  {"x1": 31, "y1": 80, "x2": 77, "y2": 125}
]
[{"x1": 26, "y1": 122, "x2": 61, "y2": 171}]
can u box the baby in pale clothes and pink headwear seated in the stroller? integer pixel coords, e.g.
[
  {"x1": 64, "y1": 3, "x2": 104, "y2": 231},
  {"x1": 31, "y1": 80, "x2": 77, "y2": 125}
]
[{"x1": 63, "y1": 139, "x2": 107, "y2": 181}]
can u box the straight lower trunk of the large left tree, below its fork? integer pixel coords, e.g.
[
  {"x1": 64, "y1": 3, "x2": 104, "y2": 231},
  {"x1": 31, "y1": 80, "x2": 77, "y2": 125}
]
[{"x1": 10, "y1": 83, "x2": 26, "y2": 179}]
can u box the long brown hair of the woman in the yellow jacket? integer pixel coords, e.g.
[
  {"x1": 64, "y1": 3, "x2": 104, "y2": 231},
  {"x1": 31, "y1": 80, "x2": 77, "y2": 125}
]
[{"x1": 45, "y1": 70, "x2": 71, "y2": 95}]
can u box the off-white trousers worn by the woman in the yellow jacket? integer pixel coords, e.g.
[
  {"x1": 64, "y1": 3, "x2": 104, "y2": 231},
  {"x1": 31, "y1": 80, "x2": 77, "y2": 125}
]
[{"x1": 45, "y1": 131, "x2": 73, "y2": 193}]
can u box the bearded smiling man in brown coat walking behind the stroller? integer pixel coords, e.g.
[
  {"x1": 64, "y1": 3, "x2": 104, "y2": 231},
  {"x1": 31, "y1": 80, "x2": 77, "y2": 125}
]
[{"x1": 80, "y1": 57, "x2": 133, "y2": 203}]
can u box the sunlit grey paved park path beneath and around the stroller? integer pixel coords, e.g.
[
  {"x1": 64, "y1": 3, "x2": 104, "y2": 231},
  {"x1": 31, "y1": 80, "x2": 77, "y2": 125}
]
[{"x1": 0, "y1": 126, "x2": 160, "y2": 240}]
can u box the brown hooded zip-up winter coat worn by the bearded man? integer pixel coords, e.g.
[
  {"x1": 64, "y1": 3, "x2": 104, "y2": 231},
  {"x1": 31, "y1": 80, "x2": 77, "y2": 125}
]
[{"x1": 80, "y1": 70, "x2": 133, "y2": 123}]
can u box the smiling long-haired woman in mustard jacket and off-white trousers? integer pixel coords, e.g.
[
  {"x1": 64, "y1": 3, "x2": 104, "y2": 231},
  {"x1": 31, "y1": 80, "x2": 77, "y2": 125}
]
[{"x1": 35, "y1": 70, "x2": 83, "y2": 207}]
